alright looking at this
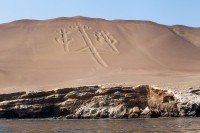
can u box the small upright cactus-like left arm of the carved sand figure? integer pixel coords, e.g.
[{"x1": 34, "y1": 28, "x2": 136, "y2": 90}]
[{"x1": 55, "y1": 28, "x2": 73, "y2": 52}]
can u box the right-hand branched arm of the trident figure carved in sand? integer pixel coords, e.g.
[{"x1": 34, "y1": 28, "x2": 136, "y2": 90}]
[{"x1": 95, "y1": 31, "x2": 119, "y2": 54}]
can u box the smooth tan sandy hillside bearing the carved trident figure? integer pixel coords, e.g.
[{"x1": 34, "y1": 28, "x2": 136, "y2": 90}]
[{"x1": 0, "y1": 17, "x2": 200, "y2": 93}]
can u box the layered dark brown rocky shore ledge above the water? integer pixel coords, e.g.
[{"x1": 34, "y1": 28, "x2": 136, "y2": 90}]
[{"x1": 0, "y1": 85, "x2": 200, "y2": 119}]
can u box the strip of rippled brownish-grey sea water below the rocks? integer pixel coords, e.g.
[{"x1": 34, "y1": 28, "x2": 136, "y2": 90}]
[{"x1": 0, "y1": 118, "x2": 200, "y2": 133}]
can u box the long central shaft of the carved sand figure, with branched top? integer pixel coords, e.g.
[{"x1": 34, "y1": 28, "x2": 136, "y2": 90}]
[{"x1": 69, "y1": 24, "x2": 108, "y2": 67}]
